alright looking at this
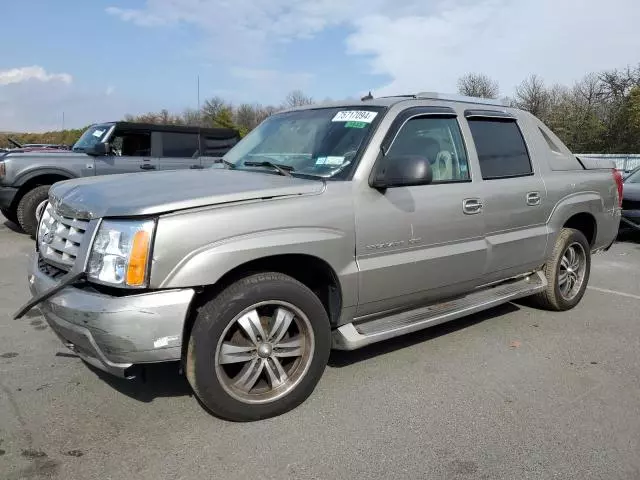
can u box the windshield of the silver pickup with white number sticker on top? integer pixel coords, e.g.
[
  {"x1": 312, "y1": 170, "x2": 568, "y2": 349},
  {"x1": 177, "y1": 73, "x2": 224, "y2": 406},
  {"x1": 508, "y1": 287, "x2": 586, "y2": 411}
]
[{"x1": 224, "y1": 107, "x2": 382, "y2": 177}]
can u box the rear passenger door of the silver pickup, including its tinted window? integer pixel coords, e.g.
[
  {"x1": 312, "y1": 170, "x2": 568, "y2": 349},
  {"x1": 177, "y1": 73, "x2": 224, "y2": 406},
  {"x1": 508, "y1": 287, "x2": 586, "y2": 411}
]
[{"x1": 465, "y1": 110, "x2": 548, "y2": 282}]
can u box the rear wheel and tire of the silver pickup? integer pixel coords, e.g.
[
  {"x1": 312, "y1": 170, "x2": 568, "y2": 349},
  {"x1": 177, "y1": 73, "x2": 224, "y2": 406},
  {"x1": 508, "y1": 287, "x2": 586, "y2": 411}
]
[{"x1": 531, "y1": 228, "x2": 591, "y2": 312}]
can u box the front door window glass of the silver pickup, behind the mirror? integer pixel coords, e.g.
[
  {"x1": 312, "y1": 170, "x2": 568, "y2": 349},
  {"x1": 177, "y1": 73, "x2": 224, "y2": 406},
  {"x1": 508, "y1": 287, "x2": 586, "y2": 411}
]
[{"x1": 387, "y1": 117, "x2": 470, "y2": 183}]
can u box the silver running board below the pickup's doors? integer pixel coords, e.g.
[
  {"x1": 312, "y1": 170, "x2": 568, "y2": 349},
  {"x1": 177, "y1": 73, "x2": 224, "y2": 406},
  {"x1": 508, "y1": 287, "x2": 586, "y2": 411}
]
[{"x1": 332, "y1": 272, "x2": 547, "y2": 350}]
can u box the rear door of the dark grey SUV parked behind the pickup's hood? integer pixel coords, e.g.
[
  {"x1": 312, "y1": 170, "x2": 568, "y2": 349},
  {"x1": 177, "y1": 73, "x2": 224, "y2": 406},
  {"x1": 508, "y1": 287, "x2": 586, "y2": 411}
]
[{"x1": 153, "y1": 132, "x2": 202, "y2": 170}]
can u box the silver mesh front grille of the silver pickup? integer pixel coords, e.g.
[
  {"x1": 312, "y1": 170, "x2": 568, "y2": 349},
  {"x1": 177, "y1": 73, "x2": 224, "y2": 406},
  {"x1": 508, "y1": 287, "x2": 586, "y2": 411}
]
[{"x1": 38, "y1": 204, "x2": 89, "y2": 271}]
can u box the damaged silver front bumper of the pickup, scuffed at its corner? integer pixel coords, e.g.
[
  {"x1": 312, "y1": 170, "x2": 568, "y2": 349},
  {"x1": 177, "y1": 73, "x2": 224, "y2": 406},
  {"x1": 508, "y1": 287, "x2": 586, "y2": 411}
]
[{"x1": 24, "y1": 252, "x2": 194, "y2": 378}]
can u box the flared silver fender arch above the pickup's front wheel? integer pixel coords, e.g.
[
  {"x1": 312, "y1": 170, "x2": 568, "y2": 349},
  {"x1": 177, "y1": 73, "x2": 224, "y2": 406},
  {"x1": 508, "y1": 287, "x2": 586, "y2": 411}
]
[{"x1": 152, "y1": 227, "x2": 358, "y2": 306}]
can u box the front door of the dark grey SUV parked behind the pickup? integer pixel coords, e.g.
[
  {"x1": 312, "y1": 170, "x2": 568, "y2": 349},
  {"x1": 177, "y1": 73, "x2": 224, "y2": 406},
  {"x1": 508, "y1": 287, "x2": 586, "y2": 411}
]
[{"x1": 96, "y1": 130, "x2": 158, "y2": 175}]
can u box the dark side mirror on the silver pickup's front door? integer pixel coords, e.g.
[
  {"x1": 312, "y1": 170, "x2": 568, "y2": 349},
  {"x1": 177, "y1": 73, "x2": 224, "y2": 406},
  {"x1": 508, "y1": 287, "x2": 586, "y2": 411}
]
[{"x1": 370, "y1": 155, "x2": 433, "y2": 188}]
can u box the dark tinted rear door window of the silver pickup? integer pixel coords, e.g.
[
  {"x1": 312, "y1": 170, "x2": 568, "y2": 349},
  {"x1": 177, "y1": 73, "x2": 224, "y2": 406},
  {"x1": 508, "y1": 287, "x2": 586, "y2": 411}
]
[{"x1": 469, "y1": 119, "x2": 533, "y2": 180}]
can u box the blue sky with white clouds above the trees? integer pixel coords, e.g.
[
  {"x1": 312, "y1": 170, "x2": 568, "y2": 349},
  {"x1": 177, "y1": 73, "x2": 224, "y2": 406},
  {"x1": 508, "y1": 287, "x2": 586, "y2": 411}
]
[{"x1": 0, "y1": 0, "x2": 640, "y2": 131}]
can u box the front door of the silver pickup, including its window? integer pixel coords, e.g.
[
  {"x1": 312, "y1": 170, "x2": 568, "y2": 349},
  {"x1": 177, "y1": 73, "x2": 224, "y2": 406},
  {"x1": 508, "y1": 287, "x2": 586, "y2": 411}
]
[{"x1": 355, "y1": 108, "x2": 486, "y2": 316}]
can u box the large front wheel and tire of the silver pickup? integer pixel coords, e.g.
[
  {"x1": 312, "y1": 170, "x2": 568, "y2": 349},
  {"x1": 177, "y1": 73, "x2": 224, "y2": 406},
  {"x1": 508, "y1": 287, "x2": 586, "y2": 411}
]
[{"x1": 186, "y1": 273, "x2": 331, "y2": 421}]
